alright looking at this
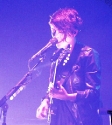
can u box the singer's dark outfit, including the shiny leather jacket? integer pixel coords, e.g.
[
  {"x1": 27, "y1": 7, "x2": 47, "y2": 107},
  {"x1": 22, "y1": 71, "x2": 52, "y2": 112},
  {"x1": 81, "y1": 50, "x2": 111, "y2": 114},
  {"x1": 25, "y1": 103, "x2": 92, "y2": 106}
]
[{"x1": 50, "y1": 42, "x2": 101, "y2": 125}]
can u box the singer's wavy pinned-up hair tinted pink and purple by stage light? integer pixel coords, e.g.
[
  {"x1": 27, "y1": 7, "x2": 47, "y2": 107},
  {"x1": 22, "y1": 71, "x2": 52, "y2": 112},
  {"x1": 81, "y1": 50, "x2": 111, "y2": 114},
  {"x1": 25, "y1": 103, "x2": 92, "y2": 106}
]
[{"x1": 49, "y1": 8, "x2": 83, "y2": 34}]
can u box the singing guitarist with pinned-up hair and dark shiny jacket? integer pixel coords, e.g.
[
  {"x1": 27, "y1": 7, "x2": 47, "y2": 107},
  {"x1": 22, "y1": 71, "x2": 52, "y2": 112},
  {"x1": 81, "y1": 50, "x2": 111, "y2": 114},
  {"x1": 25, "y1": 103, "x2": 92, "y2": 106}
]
[{"x1": 36, "y1": 8, "x2": 102, "y2": 125}]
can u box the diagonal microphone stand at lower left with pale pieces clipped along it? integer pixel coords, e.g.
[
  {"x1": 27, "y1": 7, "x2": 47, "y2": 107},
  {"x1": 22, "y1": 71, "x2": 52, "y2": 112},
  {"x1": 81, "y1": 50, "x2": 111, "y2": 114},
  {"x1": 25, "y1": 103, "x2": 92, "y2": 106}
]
[{"x1": 0, "y1": 55, "x2": 45, "y2": 125}]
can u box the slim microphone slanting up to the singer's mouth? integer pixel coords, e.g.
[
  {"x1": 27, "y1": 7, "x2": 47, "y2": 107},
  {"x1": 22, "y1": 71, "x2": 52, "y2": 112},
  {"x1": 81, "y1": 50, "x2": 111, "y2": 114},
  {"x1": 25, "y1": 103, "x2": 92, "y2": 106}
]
[{"x1": 29, "y1": 38, "x2": 57, "y2": 61}]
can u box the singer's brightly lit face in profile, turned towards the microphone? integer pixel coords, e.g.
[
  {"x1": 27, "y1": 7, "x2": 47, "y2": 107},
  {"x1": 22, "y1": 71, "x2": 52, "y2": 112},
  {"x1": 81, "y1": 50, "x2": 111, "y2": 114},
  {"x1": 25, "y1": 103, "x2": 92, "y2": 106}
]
[{"x1": 50, "y1": 24, "x2": 66, "y2": 42}]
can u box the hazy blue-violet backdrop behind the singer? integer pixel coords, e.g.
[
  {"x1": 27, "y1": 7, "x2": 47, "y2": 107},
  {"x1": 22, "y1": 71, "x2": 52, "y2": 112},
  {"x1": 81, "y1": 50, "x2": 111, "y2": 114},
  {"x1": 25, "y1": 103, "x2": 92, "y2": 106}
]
[{"x1": 0, "y1": 0, "x2": 112, "y2": 125}]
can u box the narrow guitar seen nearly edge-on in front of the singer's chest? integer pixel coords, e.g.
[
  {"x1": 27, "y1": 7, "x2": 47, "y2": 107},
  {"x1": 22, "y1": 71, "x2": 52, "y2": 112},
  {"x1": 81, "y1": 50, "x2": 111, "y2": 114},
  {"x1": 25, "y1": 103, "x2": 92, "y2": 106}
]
[{"x1": 47, "y1": 45, "x2": 71, "y2": 123}]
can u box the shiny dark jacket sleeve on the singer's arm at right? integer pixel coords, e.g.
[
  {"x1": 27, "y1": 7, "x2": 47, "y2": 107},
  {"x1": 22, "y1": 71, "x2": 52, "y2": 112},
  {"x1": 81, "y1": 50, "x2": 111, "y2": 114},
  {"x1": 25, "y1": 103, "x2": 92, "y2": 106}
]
[{"x1": 77, "y1": 49, "x2": 101, "y2": 101}]
